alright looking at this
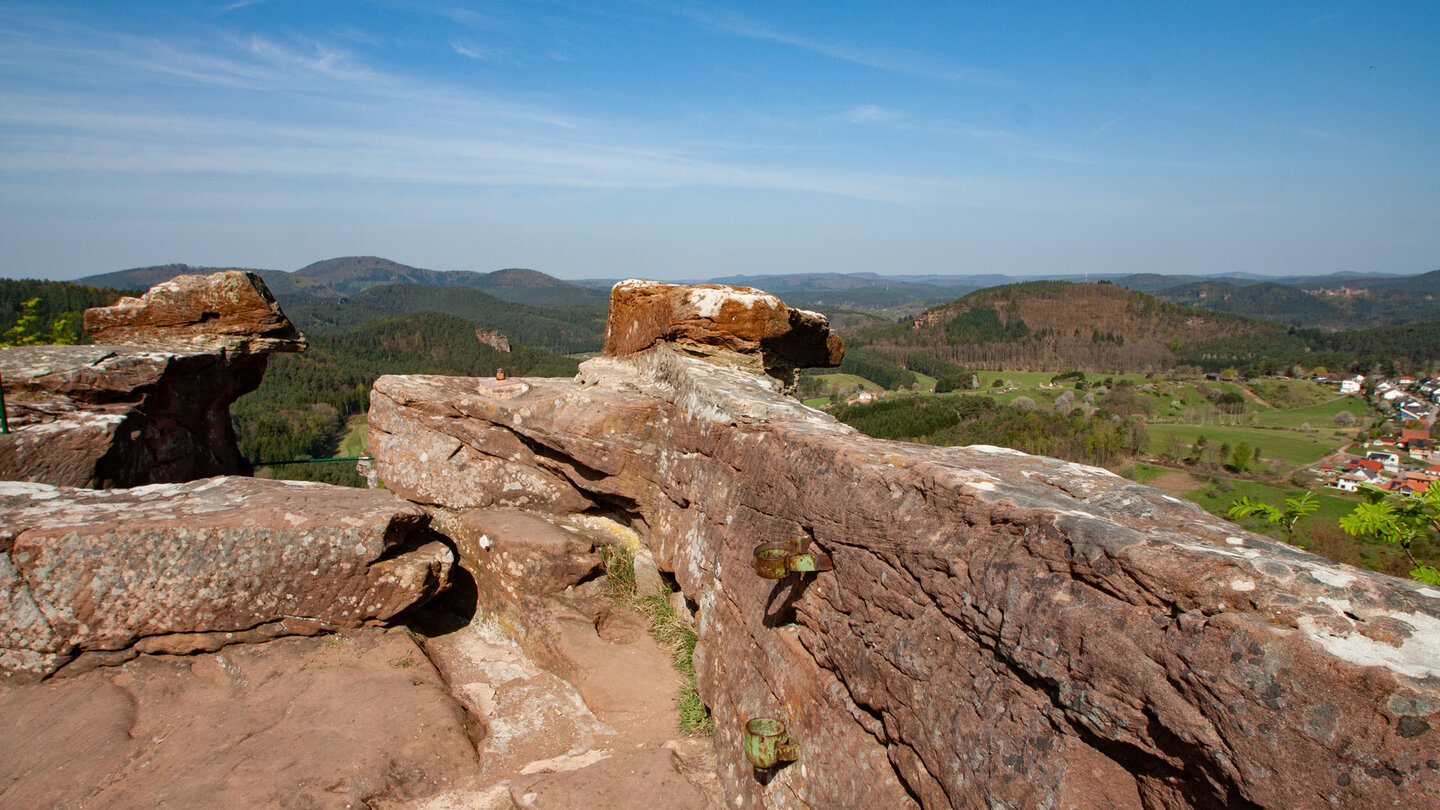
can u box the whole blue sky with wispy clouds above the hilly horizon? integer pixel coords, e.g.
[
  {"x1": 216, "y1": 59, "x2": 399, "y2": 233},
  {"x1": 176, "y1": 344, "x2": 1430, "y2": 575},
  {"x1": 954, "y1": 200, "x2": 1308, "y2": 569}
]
[{"x1": 0, "y1": 0, "x2": 1440, "y2": 280}]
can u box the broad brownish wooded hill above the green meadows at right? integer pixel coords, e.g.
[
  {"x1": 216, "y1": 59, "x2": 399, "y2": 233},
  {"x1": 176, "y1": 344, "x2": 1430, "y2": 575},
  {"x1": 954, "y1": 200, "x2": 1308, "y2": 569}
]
[{"x1": 847, "y1": 281, "x2": 1284, "y2": 372}]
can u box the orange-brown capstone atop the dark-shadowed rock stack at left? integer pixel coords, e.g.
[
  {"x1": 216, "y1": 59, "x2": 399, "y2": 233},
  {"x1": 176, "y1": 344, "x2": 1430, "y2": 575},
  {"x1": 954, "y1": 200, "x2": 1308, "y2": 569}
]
[{"x1": 85, "y1": 270, "x2": 305, "y2": 357}]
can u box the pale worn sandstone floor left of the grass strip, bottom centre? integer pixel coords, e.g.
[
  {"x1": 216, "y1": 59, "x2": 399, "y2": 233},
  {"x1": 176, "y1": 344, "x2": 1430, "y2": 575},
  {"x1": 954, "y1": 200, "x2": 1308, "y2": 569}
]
[{"x1": 406, "y1": 544, "x2": 723, "y2": 810}]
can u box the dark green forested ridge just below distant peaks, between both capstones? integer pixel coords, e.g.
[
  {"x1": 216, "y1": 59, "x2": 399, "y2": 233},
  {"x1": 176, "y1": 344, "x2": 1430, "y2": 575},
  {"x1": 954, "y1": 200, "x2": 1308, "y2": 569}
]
[{"x1": 281, "y1": 284, "x2": 605, "y2": 355}]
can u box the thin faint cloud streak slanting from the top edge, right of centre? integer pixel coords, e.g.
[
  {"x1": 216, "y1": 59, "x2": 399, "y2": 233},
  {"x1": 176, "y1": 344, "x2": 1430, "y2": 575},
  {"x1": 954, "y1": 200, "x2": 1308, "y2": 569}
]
[{"x1": 665, "y1": 6, "x2": 1015, "y2": 86}]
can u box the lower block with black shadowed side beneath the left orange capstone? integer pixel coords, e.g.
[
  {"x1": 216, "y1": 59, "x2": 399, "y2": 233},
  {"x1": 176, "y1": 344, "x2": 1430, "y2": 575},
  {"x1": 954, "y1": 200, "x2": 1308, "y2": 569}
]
[{"x1": 0, "y1": 346, "x2": 265, "y2": 487}]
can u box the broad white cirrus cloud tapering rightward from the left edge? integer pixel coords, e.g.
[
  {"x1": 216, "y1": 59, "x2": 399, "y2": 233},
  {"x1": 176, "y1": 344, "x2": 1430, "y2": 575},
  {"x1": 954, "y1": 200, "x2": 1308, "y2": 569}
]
[{"x1": 0, "y1": 22, "x2": 938, "y2": 202}]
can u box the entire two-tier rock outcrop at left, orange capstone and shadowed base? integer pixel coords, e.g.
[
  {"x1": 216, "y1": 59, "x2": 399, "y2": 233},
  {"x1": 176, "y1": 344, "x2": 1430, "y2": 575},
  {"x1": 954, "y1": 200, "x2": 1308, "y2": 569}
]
[{"x1": 0, "y1": 271, "x2": 304, "y2": 487}]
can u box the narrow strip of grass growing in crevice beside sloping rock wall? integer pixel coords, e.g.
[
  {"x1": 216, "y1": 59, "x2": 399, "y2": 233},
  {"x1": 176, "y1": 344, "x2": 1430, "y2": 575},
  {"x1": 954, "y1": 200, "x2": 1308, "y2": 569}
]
[{"x1": 600, "y1": 543, "x2": 714, "y2": 736}]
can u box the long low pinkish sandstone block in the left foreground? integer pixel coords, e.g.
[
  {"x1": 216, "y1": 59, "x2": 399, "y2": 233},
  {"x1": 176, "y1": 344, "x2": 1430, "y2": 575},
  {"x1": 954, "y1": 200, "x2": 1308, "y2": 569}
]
[{"x1": 0, "y1": 477, "x2": 454, "y2": 680}]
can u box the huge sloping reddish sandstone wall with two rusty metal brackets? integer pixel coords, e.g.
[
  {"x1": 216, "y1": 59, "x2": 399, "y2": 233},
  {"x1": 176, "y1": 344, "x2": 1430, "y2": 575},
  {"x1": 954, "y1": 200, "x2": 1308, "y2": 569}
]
[{"x1": 372, "y1": 340, "x2": 1440, "y2": 809}]
